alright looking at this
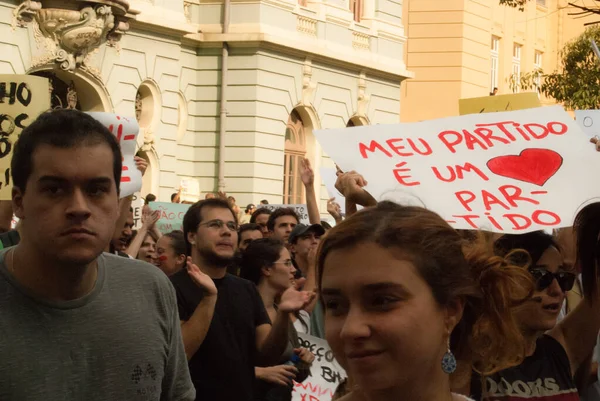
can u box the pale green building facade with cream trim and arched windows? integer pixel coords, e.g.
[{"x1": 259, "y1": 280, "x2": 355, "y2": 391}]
[{"x1": 0, "y1": 0, "x2": 411, "y2": 211}]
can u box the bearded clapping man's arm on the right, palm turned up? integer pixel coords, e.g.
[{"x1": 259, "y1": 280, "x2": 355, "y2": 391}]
[{"x1": 256, "y1": 279, "x2": 315, "y2": 366}]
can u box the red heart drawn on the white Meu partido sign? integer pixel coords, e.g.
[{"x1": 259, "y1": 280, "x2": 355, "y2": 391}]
[{"x1": 487, "y1": 149, "x2": 563, "y2": 187}]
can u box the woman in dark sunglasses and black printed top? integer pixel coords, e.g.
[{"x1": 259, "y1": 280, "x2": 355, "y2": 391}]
[{"x1": 471, "y1": 231, "x2": 598, "y2": 401}]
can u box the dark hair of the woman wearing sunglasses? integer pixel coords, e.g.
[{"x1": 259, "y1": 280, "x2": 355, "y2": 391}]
[{"x1": 494, "y1": 231, "x2": 560, "y2": 267}]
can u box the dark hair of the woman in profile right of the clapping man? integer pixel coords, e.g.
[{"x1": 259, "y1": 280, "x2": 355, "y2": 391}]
[{"x1": 240, "y1": 238, "x2": 285, "y2": 285}]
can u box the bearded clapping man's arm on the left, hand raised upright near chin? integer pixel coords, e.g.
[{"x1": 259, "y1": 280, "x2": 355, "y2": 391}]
[{"x1": 181, "y1": 258, "x2": 217, "y2": 361}]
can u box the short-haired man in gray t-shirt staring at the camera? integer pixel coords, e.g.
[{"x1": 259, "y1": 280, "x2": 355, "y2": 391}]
[{"x1": 0, "y1": 110, "x2": 195, "y2": 401}]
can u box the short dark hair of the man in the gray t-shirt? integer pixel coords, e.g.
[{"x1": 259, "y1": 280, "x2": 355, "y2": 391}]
[{"x1": 10, "y1": 109, "x2": 122, "y2": 193}]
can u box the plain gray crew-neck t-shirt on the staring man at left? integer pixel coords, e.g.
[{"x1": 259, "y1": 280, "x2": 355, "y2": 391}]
[{"x1": 0, "y1": 248, "x2": 195, "y2": 401}]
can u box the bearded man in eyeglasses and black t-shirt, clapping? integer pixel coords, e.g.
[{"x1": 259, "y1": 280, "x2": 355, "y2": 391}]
[{"x1": 171, "y1": 199, "x2": 314, "y2": 401}]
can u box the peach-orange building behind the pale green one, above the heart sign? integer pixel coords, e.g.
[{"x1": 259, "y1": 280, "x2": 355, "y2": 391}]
[{"x1": 401, "y1": 0, "x2": 598, "y2": 122}]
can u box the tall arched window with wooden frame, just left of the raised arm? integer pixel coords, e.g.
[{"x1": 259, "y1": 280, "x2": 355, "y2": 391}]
[{"x1": 283, "y1": 110, "x2": 306, "y2": 205}]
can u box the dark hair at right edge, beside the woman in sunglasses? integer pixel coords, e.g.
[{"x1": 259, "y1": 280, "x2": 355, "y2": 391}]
[{"x1": 574, "y1": 203, "x2": 600, "y2": 302}]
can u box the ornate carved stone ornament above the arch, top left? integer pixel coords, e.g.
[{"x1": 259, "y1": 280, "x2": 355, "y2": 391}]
[{"x1": 12, "y1": 0, "x2": 134, "y2": 75}]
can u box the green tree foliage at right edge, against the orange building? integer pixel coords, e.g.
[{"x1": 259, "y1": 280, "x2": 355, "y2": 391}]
[{"x1": 508, "y1": 25, "x2": 600, "y2": 110}]
